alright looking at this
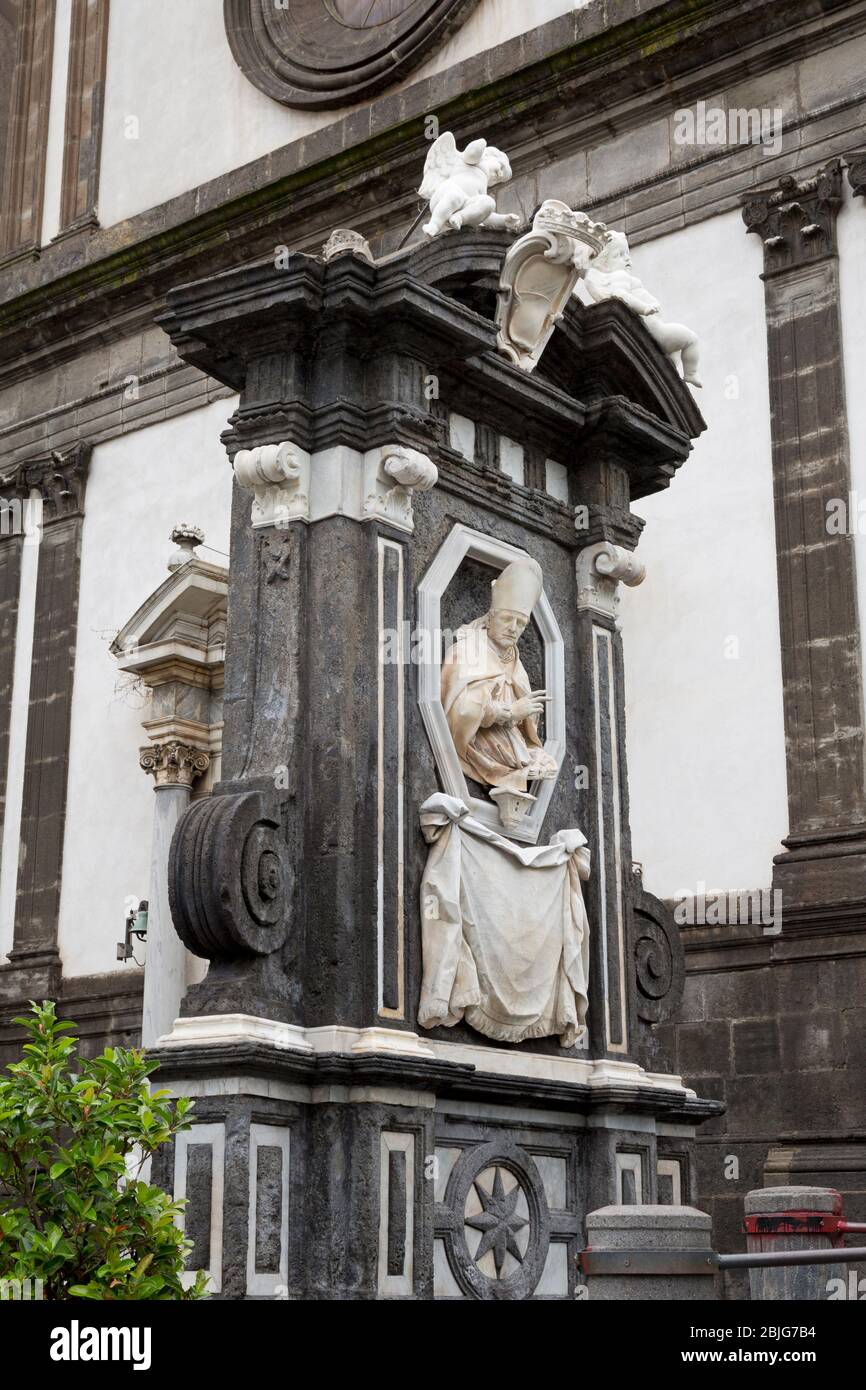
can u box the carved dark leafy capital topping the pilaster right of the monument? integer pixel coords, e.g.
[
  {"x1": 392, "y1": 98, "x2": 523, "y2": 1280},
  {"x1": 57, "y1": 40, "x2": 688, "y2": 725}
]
[{"x1": 742, "y1": 158, "x2": 842, "y2": 275}]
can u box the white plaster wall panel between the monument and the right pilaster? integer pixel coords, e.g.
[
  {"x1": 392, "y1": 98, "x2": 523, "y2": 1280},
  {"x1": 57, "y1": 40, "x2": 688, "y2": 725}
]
[{"x1": 623, "y1": 211, "x2": 787, "y2": 898}]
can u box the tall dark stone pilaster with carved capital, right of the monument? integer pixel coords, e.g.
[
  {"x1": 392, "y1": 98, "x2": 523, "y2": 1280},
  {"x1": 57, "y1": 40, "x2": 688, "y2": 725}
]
[{"x1": 744, "y1": 160, "x2": 866, "y2": 917}]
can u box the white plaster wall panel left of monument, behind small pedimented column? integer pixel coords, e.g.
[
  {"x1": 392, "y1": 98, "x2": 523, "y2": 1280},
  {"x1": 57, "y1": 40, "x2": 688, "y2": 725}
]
[{"x1": 58, "y1": 400, "x2": 235, "y2": 976}]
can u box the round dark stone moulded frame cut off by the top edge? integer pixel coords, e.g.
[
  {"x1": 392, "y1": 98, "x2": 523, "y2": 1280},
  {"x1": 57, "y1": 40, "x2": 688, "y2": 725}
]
[{"x1": 224, "y1": 0, "x2": 478, "y2": 110}]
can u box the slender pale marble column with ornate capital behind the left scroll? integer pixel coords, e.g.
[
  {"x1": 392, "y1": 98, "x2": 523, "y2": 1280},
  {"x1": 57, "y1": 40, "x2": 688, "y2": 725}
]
[{"x1": 139, "y1": 741, "x2": 210, "y2": 1047}]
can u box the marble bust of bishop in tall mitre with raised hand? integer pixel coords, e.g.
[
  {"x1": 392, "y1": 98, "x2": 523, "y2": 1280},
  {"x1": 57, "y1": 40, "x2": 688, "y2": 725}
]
[{"x1": 441, "y1": 556, "x2": 556, "y2": 792}]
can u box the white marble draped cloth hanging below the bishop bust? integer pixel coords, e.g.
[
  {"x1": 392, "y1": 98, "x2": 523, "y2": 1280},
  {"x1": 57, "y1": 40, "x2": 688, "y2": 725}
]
[{"x1": 418, "y1": 794, "x2": 589, "y2": 1047}]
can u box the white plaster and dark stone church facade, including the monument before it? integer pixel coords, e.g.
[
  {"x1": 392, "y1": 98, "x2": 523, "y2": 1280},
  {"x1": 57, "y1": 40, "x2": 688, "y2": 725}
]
[{"x1": 0, "y1": 0, "x2": 866, "y2": 1300}]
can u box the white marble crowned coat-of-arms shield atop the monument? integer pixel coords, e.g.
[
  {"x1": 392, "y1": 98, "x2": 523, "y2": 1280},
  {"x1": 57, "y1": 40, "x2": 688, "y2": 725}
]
[{"x1": 496, "y1": 199, "x2": 607, "y2": 371}]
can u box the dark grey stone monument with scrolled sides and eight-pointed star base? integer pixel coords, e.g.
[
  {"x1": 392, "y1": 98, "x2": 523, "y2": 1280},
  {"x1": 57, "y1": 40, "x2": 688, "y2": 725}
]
[{"x1": 154, "y1": 229, "x2": 719, "y2": 1300}]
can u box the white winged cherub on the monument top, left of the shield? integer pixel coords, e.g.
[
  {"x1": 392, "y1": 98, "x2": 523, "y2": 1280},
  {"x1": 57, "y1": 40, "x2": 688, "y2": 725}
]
[{"x1": 418, "y1": 131, "x2": 520, "y2": 238}]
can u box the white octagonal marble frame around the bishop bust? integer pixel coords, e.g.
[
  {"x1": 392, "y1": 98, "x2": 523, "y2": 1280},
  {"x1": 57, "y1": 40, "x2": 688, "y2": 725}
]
[{"x1": 418, "y1": 523, "x2": 566, "y2": 845}]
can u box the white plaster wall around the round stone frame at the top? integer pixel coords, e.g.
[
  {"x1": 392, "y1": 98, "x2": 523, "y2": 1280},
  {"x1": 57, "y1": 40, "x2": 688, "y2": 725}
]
[{"x1": 99, "y1": 0, "x2": 588, "y2": 227}]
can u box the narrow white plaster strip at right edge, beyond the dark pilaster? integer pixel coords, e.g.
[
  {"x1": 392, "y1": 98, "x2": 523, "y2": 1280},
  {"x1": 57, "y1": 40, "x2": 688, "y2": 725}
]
[{"x1": 837, "y1": 200, "x2": 866, "y2": 717}]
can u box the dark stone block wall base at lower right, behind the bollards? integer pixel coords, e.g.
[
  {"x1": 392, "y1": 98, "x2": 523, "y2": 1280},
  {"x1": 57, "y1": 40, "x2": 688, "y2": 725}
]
[{"x1": 657, "y1": 927, "x2": 866, "y2": 1298}]
